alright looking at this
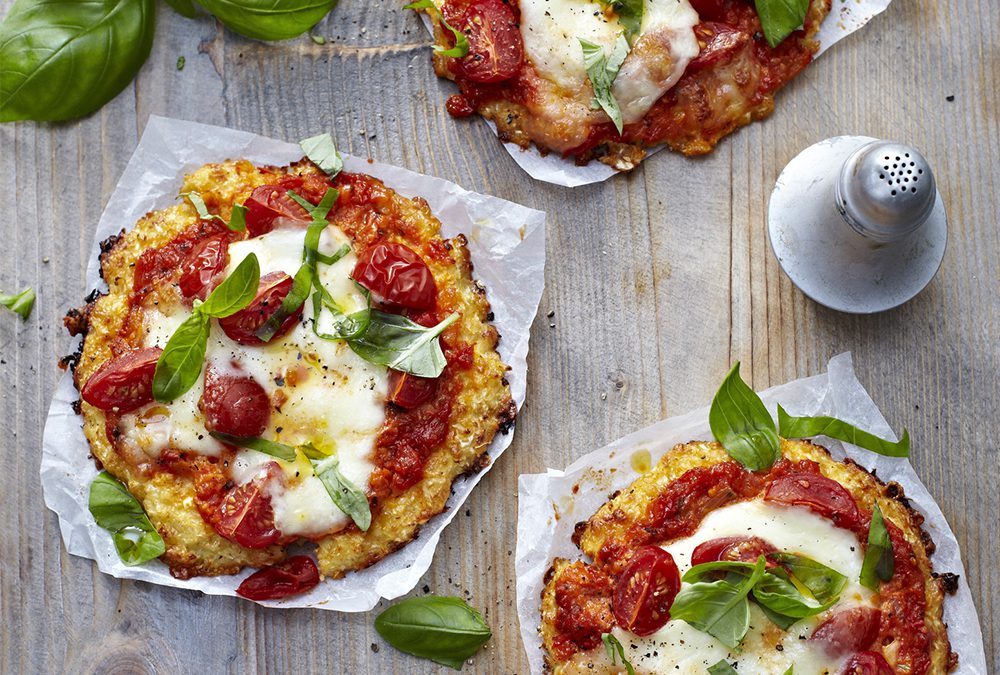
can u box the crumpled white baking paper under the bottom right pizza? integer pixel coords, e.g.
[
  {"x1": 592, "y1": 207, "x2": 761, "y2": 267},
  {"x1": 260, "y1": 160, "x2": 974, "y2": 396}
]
[{"x1": 515, "y1": 353, "x2": 987, "y2": 675}]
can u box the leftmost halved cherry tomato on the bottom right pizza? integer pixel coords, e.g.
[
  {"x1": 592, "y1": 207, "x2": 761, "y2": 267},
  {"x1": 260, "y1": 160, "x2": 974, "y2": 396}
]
[{"x1": 611, "y1": 546, "x2": 681, "y2": 636}]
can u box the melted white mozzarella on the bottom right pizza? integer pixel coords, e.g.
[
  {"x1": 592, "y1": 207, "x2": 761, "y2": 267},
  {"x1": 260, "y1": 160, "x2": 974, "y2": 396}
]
[{"x1": 614, "y1": 500, "x2": 874, "y2": 675}]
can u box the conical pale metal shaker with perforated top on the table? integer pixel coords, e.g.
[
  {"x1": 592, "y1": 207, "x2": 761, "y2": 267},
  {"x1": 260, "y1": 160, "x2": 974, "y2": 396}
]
[{"x1": 768, "y1": 136, "x2": 947, "y2": 314}]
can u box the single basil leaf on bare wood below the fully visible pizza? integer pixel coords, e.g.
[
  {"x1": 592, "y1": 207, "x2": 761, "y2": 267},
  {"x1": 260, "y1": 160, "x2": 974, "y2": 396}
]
[{"x1": 375, "y1": 595, "x2": 492, "y2": 670}]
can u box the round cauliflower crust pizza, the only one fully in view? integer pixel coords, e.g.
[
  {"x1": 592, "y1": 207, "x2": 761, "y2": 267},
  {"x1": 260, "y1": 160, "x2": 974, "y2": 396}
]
[{"x1": 67, "y1": 146, "x2": 515, "y2": 599}]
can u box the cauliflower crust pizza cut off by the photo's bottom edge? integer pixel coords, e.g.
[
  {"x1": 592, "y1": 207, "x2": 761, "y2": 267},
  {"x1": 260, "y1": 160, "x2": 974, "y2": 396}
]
[{"x1": 541, "y1": 439, "x2": 957, "y2": 675}]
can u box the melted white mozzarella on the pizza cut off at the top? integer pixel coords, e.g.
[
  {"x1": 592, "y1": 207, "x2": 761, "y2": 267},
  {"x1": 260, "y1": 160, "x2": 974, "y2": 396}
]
[{"x1": 520, "y1": 0, "x2": 699, "y2": 124}]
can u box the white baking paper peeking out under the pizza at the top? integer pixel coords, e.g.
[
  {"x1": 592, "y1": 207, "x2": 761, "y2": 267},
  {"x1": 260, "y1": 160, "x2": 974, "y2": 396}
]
[{"x1": 421, "y1": 0, "x2": 890, "y2": 187}]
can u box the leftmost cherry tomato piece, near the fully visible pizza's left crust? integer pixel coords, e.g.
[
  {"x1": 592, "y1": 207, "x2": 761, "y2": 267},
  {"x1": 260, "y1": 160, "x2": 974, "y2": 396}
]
[{"x1": 80, "y1": 347, "x2": 163, "y2": 413}]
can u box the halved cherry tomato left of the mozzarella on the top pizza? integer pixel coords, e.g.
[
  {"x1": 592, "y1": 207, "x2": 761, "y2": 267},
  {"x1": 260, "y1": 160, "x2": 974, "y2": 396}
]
[{"x1": 458, "y1": 0, "x2": 524, "y2": 83}]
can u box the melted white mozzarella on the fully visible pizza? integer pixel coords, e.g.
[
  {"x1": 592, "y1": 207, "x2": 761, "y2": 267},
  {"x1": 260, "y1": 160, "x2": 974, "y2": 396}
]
[{"x1": 114, "y1": 225, "x2": 388, "y2": 536}]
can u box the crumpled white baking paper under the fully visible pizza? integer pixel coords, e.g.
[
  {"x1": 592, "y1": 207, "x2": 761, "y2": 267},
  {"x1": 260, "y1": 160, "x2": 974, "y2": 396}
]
[{"x1": 41, "y1": 116, "x2": 545, "y2": 612}]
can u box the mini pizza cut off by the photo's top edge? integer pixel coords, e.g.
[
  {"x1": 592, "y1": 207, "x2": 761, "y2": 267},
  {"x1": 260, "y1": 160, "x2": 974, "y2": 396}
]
[{"x1": 410, "y1": 0, "x2": 831, "y2": 171}]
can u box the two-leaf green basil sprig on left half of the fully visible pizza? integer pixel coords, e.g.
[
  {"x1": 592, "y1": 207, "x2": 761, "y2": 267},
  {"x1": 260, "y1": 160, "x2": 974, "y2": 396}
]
[{"x1": 153, "y1": 253, "x2": 260, "y2": 403}]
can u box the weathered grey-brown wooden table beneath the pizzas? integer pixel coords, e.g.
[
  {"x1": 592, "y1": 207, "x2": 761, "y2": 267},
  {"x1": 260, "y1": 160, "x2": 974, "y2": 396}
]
[{"x1": 0, "y1": 0, "x2": 1000, "y2": 673}]
